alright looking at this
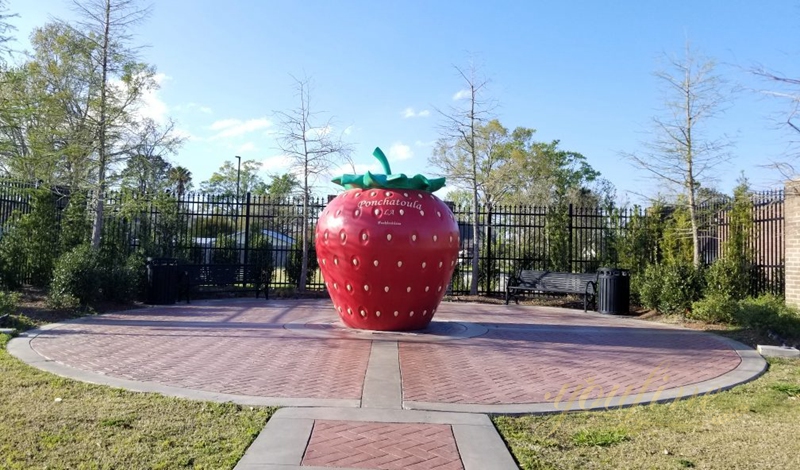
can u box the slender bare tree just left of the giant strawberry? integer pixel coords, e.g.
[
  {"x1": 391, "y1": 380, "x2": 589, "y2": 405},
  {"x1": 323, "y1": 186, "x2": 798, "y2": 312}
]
[{"x1": 275, "y1": 77, "x2": 350, "y2": 291}]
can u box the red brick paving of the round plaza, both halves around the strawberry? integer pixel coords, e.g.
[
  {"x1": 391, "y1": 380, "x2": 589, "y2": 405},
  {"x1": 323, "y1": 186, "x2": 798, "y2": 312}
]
[{"x1": 31, "y1": 300, "x2": 739, "y2": 404}]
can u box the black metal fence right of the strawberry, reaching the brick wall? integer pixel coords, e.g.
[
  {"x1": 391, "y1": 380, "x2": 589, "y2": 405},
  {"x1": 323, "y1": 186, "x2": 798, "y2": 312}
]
[{"x1": 451, "y1": 190, "x2": 785, "y2": 295}]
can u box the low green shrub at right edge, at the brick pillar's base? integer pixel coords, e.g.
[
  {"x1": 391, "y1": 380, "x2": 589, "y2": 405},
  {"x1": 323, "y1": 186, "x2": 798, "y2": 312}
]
[{"x1": 735, "y1": 294, "x2": 800, "y2": 339}]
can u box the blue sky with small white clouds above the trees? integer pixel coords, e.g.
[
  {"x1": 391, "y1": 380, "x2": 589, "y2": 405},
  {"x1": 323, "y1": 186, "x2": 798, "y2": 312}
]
[{"x1": 9, "y1": 0, "x2": 800, "y2": 200}]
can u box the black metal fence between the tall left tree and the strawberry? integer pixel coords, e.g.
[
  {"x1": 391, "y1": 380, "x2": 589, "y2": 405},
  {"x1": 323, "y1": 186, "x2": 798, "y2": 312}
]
[{"x1": 103, "y1": 193, "x2": 326, "y2": 290}]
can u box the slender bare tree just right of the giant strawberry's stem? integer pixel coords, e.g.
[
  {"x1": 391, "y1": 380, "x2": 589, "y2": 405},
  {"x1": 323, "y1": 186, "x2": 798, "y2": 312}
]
[{"x1": 430, "y1": 65, "x2": 493, "y2": 295}]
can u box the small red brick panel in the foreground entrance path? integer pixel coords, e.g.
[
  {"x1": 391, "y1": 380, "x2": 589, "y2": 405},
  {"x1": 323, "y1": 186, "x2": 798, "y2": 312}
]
[{"x1": 302, "y1": 420, "x2": 464, "y2": 470}]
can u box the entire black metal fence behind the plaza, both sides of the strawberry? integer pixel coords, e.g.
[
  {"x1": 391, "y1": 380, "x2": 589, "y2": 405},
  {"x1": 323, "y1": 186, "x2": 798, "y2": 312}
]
[{"x1": 0, "y1": 180, "x2": 784, "y2": 295}]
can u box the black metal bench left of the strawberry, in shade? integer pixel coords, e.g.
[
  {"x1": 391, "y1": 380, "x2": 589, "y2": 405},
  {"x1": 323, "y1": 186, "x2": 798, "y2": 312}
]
[{"x1": 178, "y1": 264, "x2": 269, "y2": 304}]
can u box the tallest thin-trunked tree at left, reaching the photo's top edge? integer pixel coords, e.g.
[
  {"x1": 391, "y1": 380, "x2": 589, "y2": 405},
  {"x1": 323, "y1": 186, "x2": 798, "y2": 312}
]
[{"x1": 72, "y1": 0, "x2": 154, "y2": 248}]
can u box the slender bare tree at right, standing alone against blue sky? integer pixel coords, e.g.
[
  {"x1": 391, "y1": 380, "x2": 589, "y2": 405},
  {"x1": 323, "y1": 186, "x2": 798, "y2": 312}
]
[{"x1": 624, "y1": 42, "x2": 731, "y2": 266}]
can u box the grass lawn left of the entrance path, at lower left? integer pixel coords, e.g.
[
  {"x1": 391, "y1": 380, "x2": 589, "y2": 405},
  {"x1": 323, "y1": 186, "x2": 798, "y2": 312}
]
[{"x1": 0, "y1": 335, "x2": 274, "y2": 470}]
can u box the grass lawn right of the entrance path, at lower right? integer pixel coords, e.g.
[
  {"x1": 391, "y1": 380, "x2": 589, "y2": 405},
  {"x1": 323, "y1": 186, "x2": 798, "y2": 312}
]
[{"x1": 494, "y1": 360, "x2": 800, "y2": 470}]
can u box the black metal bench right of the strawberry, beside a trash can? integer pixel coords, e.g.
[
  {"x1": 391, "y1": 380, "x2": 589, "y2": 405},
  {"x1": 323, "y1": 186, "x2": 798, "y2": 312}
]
[{"x1": 506, "y1": 270, "x2": 597, "y2": 312}]
